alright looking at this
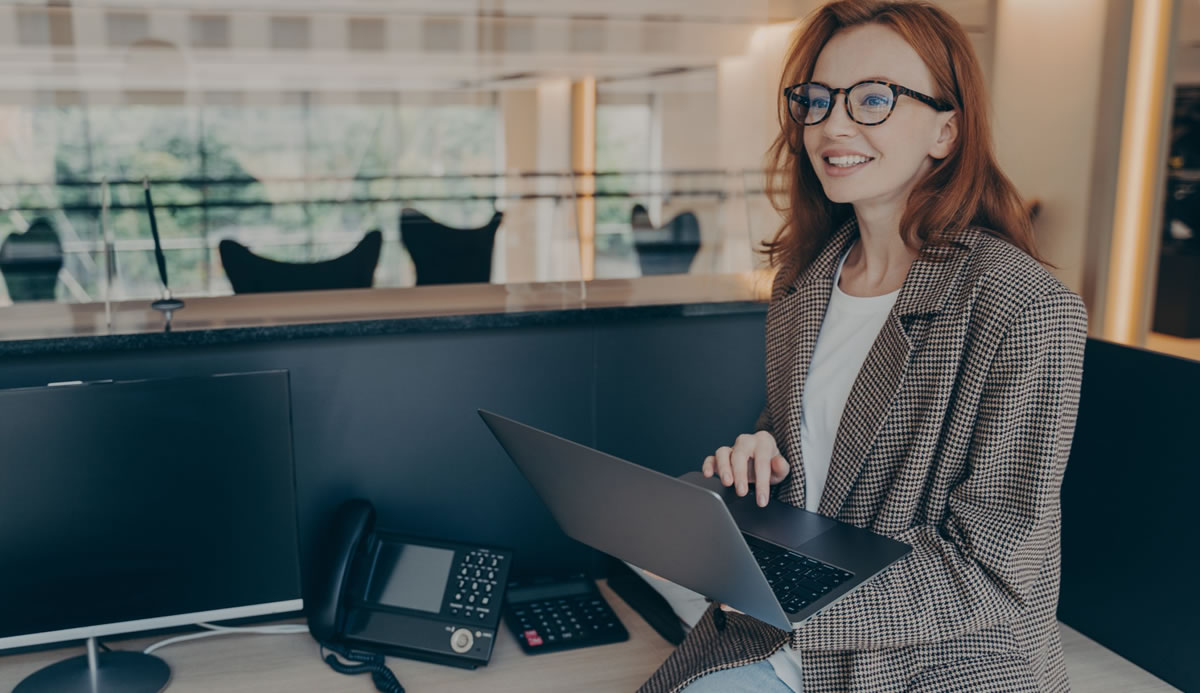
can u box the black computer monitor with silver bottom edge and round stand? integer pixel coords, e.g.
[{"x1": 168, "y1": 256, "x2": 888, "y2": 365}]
[{"x1": 0, "y1": 370, "x2": 302, "y2": 692}]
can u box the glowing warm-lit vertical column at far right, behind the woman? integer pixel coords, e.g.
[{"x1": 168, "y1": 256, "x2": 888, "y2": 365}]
[{"x1": 1103, "y1": 0, "x2": 1176, "y2": 345}]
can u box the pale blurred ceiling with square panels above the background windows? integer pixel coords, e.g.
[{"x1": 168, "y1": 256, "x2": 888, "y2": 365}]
[{"x1": 11, "y1": 0, "x2": 1180, "y2": 92}]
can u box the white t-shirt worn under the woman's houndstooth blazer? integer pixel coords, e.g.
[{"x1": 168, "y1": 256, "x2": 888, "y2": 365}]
[{"x1": 631, "y1": 245, "x2": 900, "y2": 693}]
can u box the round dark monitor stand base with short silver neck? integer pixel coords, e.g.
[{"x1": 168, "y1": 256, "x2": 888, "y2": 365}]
[{"x1": 12, "y1": 638, "x2": 170, "y2": 693}]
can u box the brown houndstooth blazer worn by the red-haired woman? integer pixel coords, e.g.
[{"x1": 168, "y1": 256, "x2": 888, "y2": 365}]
[{"x1": 641, "y1": 221, "x2": 1087, "y2": 693}]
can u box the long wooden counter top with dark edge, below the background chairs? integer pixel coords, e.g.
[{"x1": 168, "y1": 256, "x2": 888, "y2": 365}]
[{"x1": 0, "y1": 272, "x2": 770, "y2": 356}]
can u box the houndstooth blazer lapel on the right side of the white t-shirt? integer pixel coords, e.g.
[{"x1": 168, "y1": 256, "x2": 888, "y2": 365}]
[{"x1": 816, "y1": 230, "x2": 973, "y2": 517}]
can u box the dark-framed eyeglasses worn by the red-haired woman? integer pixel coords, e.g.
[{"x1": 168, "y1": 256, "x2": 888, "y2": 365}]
[{"x1": 784, "y1": 79, "x2": 954, "y2": 125}]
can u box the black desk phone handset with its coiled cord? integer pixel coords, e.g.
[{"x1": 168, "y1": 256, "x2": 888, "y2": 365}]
[{"x1": 305, "y1": 499, "x2": 404, "y2": 693}]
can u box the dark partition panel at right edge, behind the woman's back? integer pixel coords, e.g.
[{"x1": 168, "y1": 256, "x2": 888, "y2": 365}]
[{"x1": 1058, "y1": 339, "x2": 1200, "y2": 691}]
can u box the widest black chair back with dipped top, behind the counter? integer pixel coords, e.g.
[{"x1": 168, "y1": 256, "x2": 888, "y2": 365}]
[{"x1": 217, "y1": 230, "x2": 383, "y2": 294}]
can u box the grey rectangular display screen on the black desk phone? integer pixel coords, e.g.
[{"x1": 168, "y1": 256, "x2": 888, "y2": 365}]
[{"x1": 366, "y1": 541, "x2": 454, "y2": 614}]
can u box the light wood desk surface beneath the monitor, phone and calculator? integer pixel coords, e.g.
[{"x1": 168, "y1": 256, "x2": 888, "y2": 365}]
[{"x1": 0, "y1": 580, "x2": 673, "y2": 693}]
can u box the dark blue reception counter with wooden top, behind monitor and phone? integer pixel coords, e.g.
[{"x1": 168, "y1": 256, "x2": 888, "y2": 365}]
[{"x1": 0, "y1": 269, "x2": 769, "y2": 582}]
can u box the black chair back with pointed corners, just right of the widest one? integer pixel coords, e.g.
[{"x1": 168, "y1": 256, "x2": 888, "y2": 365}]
[{"x1": 400, "y1": 207, "x2": 504, "y2": 287}]
